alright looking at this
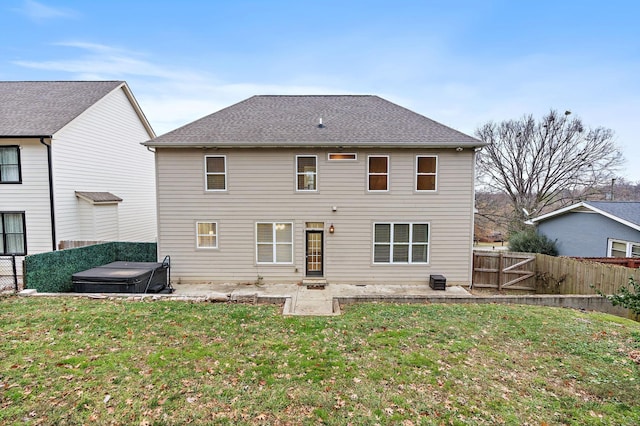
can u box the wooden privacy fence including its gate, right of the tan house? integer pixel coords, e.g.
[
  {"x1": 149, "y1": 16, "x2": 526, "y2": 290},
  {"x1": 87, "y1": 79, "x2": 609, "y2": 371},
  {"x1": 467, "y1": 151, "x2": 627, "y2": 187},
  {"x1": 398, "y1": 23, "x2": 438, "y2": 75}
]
[{"x1": 473, "y1": 251, "x2": 640, "y2": 294}]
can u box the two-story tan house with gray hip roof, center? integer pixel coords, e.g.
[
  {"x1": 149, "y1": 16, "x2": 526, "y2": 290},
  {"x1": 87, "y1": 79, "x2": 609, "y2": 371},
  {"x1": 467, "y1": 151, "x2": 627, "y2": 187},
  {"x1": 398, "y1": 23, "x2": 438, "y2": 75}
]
[{"x1": 145, "y1": 96, "x2": 483, "y2": 284}]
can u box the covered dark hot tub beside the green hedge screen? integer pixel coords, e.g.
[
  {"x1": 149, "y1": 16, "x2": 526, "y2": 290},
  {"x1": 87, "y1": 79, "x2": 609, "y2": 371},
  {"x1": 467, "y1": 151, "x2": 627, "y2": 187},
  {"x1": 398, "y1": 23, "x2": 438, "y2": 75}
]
[{"x1": 71, "y1": 261, "x2": 173, "y2": 293}]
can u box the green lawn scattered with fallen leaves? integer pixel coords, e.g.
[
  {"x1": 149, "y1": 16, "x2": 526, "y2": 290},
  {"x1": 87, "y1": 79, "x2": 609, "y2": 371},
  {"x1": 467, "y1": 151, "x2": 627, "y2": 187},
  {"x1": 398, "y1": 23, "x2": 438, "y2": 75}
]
[{"x1": 0, "y1": 297, "x2": 640, "y2": 425}]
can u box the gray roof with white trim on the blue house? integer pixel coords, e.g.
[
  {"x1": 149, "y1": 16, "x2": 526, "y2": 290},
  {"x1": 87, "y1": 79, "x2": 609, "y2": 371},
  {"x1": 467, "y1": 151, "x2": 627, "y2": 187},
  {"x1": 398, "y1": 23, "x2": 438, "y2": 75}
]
[{"x1": 530, "y1": 201, "x2": 640, "y2": 231}]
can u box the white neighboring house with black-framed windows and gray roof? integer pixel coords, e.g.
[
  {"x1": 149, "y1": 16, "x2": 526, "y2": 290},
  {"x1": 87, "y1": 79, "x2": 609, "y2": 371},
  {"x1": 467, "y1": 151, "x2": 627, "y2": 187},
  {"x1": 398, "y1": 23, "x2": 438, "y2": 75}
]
[{"x1": 0, "y1": 81, "x2": 157, "y2": 284}]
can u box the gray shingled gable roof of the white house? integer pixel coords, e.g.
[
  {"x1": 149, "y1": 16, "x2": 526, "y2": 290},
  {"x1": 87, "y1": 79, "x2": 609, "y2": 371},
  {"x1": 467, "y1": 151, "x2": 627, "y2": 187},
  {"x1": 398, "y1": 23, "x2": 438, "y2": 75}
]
[{"x1": 0, "y1": 81, "x2": 155, "y2": 137}]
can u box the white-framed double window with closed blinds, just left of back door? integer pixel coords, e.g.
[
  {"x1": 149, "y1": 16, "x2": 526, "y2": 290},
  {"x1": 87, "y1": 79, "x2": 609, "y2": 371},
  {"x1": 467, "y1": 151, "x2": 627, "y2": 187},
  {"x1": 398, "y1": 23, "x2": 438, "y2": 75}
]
[{"x1": 256, "y1": 222, "x2": 293, "y2": 263}]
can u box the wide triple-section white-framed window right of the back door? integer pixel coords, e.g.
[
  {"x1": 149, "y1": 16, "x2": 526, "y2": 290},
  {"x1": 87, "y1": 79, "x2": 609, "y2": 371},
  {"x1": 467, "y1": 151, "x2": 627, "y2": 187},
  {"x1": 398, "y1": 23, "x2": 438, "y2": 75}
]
[{"x1": 373, "y1": 223, "x2": 429, "y2": 263}]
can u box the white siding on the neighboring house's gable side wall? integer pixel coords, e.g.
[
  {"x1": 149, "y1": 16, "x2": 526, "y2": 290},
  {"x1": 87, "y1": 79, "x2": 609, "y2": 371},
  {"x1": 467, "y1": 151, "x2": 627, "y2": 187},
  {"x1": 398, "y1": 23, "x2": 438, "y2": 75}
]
[{"x1": 52, "y1": 89, "x2": 157, "y2": 245}]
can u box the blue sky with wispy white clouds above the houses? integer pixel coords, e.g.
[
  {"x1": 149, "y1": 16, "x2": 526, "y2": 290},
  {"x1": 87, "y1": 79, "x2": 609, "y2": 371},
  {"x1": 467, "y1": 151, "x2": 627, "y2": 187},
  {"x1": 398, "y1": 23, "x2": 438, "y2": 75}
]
[{"x1": 0, "y1": 0, "x2": 640, "y2": 181}]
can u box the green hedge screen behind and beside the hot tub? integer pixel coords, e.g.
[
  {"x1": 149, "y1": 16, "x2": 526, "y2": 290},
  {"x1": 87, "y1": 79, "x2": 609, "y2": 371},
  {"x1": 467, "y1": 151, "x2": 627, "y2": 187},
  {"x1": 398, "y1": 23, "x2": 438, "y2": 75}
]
[{"x1": 24, "y1": 242, "x2": 157, "y2": 293}]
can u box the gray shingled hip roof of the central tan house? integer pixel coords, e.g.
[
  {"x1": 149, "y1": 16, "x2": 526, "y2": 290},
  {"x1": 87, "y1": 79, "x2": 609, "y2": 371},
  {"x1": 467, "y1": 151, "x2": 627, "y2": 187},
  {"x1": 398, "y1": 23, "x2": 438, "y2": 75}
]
[{"x1": 145, "y1": 95, "x2": 485, "y2": 148}]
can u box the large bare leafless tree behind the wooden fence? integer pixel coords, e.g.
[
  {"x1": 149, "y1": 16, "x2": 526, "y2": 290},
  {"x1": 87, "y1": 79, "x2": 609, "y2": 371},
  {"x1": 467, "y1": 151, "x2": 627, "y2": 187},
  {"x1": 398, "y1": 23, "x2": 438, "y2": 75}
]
[{"x1": 476, "y1": 110, "x2": 624, "y2": 231}]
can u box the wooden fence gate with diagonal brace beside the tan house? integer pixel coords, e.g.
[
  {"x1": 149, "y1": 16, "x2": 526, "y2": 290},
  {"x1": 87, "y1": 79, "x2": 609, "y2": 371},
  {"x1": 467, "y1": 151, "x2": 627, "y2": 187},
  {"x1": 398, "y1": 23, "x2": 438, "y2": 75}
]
[{"x1": 473, "y1": 251, "x2": 536, "y2": 291}]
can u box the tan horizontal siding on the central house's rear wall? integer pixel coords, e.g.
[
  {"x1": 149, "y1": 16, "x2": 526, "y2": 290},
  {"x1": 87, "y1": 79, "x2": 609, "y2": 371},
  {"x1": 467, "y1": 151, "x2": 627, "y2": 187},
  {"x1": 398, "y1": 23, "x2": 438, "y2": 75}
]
[{"x1": 156, "y1": 148, "x2": 473, "y2": 284}]
